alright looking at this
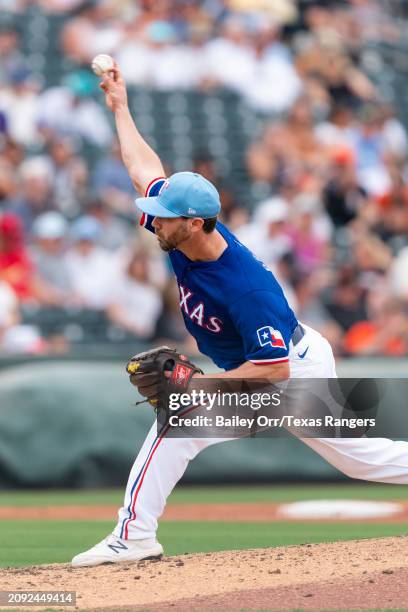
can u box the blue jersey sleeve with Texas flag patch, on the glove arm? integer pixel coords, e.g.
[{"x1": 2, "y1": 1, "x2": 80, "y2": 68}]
[{"x1": 230, "y1": 291, "x2": 292, "y2": 365}]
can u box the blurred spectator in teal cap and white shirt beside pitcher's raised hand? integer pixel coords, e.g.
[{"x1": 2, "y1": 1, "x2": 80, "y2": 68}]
[{"x1": 37, "y1": 70, "x2": 113, "y2": 147}]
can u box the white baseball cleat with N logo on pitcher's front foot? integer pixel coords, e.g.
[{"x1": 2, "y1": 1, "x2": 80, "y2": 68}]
[{"x1": 71, "y1": 533, "x2": 163, "y2": 567}]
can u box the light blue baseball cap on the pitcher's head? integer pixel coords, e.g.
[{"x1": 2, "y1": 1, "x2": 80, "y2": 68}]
[{"x1": 136, "y1": 172, "x2": 221, "y2": 219}]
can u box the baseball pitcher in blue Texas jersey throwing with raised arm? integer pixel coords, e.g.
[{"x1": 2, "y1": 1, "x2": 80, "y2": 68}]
[{"x1": 72, "y1": 65, "x2": 408, "y2": 566}]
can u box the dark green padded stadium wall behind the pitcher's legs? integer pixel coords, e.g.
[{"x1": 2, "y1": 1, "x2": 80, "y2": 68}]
[{"x1": 0, "y1": 358, "x2": 408, "y2": 488}]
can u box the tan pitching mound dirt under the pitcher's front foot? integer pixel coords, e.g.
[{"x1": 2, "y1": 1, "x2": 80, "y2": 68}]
[{"x1": 0, "y1": 536, "x2": 408, "y2": 612}]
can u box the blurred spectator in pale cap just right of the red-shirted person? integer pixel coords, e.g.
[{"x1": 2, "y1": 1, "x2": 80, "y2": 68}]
[{"x1": 30, "y1": 212, "x2": 74, "y2": 306}]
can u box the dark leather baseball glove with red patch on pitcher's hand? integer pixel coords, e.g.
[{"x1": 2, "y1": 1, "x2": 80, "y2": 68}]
[{"x1": 126, "y1": 346, "x2": 203, "y2": 410}]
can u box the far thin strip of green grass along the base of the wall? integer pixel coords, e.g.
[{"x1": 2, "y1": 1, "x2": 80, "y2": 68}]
[{"x1": 0, "y1": 483, "x2": 408, "y2": 506}]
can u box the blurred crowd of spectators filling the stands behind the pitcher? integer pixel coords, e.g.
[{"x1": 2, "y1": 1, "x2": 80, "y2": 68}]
[{"x1": 0, "y1": 0, "x2": 408, "y2": 356}]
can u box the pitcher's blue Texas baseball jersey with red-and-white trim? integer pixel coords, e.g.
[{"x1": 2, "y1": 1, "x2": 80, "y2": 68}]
[{"x1": 140, "y1": 178, "x2": 298, "y2": 370}]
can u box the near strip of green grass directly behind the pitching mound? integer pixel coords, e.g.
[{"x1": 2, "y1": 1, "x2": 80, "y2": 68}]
[{"x1": 0, "y1": 521, "x2": 408, "y2": 567}]
